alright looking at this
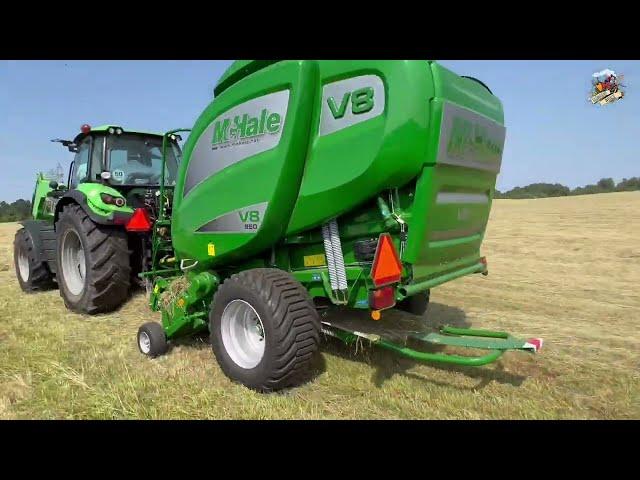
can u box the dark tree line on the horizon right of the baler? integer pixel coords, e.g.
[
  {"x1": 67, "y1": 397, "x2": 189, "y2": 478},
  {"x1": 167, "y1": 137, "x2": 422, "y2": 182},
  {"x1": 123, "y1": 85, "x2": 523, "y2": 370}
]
[{"x1": 494, "y1": 177, "x2": 640, "y2": 199}]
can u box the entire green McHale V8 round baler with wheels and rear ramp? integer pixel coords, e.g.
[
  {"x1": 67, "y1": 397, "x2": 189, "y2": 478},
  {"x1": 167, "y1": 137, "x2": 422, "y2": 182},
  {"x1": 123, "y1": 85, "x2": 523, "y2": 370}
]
[{"x1": 132, "y1": 60, "x2": 542, "y2": 391}]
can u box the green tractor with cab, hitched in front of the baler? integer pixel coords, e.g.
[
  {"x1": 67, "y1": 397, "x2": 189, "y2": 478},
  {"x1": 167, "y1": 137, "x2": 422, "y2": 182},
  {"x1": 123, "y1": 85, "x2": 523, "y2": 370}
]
[{"x1": 14, "y1": 124, "x2": 181, "y2": 314}]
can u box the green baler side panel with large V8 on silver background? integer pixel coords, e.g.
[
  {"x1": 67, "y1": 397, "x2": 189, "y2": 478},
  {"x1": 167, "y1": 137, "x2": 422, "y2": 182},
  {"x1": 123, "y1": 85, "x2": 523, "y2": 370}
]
[{"x1": 287, "y1": 60, "x2": 435, "y2": 235}]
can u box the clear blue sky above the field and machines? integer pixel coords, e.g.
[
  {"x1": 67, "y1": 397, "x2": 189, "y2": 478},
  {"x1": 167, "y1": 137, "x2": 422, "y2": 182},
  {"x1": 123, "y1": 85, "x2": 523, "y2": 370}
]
[{"x1": 0, "y1": 60, "x2": 640, "y2": 201}]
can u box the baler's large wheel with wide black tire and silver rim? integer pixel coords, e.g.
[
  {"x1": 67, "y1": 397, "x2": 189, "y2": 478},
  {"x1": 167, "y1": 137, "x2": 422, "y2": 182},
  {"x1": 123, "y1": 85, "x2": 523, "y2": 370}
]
[{"x1": 209, "y1": 268, "x2": 320, "y2": 392}]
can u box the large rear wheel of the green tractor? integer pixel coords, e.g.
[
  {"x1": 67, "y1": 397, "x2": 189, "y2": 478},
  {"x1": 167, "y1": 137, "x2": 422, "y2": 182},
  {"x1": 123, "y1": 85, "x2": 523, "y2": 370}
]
[{"x1": 56, "y1": 204, "x2": 131, "y2": 314}]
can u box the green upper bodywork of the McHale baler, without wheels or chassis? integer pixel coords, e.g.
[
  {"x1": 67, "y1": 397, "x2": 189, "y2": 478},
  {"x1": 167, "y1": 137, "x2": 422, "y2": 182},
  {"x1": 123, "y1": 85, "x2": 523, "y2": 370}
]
[{"x1": 172, "y1": 60, "x2": 505, "y2": 283}]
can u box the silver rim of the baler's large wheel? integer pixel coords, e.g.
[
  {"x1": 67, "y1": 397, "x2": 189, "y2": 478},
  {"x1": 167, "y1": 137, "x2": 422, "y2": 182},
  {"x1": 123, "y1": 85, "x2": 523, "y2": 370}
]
[{"x1": 221, "y1": 300, "x2": 265, "y2": 369}]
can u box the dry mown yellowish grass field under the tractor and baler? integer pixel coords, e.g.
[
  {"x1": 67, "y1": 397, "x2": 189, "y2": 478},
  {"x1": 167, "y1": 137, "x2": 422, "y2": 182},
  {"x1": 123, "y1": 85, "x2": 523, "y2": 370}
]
[{"x1": 0, "y1": 192, "x2": 640, "y2": 419}]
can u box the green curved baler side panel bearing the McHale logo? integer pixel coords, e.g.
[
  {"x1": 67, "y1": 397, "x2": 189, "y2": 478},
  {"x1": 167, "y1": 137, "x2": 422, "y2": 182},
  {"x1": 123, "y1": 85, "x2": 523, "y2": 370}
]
[{"x1": 172, "y1": 61, "x2": 318, "y2": 268}]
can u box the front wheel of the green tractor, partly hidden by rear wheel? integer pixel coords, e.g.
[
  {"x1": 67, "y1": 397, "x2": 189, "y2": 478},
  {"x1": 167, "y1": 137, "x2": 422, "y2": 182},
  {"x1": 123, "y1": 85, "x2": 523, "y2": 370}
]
[{"x1": 13, "y1": 228, "x2": 55, "y2": 293}]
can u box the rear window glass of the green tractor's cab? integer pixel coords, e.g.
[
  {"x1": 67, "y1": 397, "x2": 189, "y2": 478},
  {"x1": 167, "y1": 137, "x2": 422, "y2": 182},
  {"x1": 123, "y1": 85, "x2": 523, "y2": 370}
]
[{"x1": 106, "y1": 133, "x2": 180, "y2": 186}]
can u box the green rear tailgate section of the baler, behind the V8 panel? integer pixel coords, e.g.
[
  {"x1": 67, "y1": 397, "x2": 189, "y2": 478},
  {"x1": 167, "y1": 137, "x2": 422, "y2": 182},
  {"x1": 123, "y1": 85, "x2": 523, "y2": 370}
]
[{"x1": 402, "y1": 65, "x2": 505, "y2": 283}]
